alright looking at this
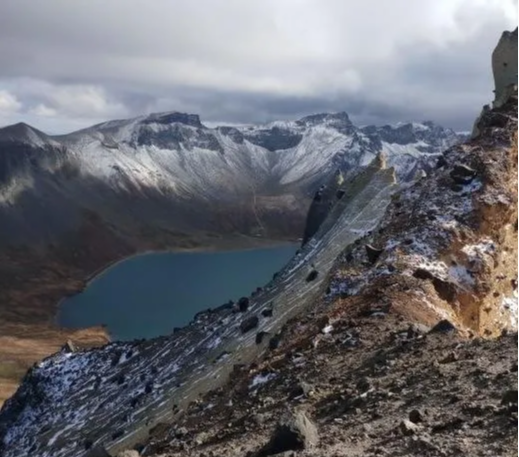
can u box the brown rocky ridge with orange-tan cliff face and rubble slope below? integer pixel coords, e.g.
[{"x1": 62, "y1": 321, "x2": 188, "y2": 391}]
[{"x1": 138, "y1": 82, "x2": 518, "y2": 457}]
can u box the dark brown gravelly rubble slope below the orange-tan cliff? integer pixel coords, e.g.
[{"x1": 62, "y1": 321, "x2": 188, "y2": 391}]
[{"x1": 146, "y1": 318, "x2": 518, "y2": 457}]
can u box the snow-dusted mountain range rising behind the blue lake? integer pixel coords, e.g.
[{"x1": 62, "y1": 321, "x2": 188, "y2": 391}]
[{"x1": 0, "y1": 113, "x2": 461, "y2": 246}]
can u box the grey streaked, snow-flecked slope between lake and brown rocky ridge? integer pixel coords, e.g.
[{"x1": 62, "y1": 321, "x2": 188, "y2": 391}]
[{"x1": 0, "y1": 155, "x2": 402, "y2": 457}]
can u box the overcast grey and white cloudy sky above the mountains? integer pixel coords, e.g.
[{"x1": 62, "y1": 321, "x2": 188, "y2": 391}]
[{"x1": 0, "y1": 0, "x2": 518, "y2": 133}]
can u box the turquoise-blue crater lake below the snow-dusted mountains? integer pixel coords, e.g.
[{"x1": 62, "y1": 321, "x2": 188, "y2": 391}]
[{"x1": 58, "y1": 245, "x2": 298, "y2": 341}]
